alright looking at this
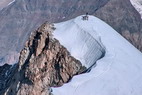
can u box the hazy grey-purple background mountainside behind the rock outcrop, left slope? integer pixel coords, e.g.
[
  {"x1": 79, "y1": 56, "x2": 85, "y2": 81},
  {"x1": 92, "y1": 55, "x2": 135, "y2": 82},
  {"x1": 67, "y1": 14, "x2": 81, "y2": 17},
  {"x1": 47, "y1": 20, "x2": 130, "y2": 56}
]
[{"x1": 0, "y1": 0, "x2": 108, "y2": 64}]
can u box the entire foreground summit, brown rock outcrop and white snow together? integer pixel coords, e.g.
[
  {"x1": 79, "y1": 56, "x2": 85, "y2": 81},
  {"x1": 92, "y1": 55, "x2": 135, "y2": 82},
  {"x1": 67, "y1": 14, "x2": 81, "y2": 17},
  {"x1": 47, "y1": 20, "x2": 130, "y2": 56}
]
[{"x1": 0, "y1": 16, "x2": 142, "y2": 95}]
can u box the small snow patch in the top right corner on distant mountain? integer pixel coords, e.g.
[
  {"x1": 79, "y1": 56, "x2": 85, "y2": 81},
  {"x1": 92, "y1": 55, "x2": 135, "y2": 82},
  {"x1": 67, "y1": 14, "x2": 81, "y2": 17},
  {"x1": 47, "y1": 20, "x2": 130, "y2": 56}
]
[{"x1": 130, "y1": 0, "x2": 142, "y2": 18}]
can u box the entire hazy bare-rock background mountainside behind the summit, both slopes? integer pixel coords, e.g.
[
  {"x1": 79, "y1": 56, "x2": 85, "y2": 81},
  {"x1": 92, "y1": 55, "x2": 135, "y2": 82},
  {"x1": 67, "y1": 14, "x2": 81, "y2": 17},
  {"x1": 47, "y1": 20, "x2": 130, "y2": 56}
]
[{"x1": 0, "y1": 0, "x2": 142, "y2": 65}]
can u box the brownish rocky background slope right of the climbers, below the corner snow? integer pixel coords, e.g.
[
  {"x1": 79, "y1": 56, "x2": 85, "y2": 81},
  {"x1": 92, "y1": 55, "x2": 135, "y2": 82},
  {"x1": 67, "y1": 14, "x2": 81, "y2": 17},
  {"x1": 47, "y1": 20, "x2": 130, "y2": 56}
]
[{"x1": 94, "y1": 0, "x2": 142, "y2": 51}]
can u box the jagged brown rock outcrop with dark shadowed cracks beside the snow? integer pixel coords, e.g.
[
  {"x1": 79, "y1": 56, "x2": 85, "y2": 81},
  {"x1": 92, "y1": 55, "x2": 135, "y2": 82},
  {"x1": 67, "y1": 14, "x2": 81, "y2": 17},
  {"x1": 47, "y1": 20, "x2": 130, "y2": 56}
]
[{"x1": 0, "y1": 22, "x2": 86, "y2": 95}]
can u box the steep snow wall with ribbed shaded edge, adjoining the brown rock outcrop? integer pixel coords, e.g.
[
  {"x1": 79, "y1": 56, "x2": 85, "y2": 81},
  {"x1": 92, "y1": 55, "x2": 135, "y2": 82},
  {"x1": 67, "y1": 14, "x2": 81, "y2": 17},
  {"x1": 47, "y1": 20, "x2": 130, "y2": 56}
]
[{"x1": 53, "y1": 19, "x2": 105, "y2": 68}]
